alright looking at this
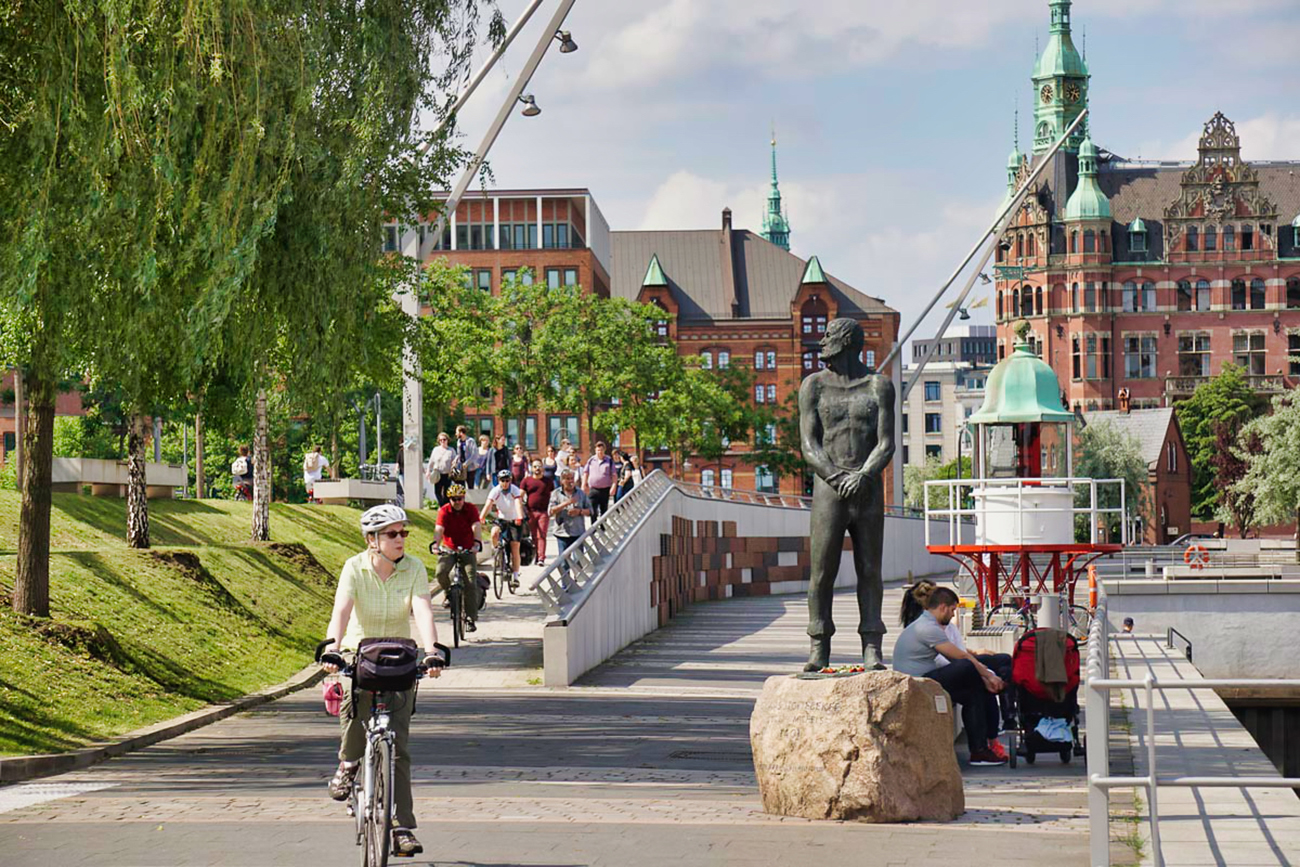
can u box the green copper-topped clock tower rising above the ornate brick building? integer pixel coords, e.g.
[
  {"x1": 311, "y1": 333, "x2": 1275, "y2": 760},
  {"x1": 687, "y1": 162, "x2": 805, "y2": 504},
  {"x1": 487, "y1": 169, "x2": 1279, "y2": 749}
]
[{"x1": 1034, "y1": 0, "x2": 1089, "y2": 153}]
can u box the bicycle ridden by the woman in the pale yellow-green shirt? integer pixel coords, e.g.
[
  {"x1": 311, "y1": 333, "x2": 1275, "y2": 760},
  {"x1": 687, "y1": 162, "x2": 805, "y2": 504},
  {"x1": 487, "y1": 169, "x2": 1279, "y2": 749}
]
[{"x1": 316, "y1": 638, "x2": 451, "y2": 867}]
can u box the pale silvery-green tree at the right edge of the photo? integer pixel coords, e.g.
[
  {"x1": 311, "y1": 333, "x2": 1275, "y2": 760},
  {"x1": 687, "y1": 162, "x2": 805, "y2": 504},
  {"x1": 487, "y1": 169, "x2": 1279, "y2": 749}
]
[{"x1": 1234, "y1": 394, "x2": 1300, "y2": 562}]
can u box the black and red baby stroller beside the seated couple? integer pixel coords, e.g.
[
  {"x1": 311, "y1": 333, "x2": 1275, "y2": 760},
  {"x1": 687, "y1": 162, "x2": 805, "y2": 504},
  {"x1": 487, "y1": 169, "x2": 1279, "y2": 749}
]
[{"x1": 1004, "y1": 628, "x2": 1084, "y2": 768}]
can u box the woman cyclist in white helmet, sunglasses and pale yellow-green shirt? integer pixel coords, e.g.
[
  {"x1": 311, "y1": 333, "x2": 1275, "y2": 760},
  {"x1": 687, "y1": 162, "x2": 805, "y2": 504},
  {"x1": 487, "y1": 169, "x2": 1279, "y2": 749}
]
[{"x1": 322, "y1": 503, "x2": 442, "y2": 855}]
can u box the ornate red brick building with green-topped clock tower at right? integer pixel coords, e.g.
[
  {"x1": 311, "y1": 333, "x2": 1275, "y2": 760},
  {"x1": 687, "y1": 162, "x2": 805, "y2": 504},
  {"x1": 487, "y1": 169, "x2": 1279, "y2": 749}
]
[{"x1": 995, "y1": 0, "x2": 1300, "y2": 412}]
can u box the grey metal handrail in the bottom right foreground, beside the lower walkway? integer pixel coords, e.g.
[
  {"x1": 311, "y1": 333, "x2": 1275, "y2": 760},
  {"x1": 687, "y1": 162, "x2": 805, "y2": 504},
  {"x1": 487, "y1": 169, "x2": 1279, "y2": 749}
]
[{"x1": 1084, "y1": 581, "x2": 1300, "y2": 867}]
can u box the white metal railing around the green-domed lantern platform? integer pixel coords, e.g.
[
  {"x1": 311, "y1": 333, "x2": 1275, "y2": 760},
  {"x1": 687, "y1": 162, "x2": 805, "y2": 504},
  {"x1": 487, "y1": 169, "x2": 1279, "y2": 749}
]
[{"x1": 926, "y1": 477, "x2": 1126, "y2": 545}]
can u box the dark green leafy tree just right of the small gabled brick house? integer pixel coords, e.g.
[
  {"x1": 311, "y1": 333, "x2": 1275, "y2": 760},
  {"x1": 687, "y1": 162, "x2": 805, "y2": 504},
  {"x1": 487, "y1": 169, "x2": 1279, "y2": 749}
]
[{"x1": 1175, "y1": 361, "x2": 1266, "y2": 520}]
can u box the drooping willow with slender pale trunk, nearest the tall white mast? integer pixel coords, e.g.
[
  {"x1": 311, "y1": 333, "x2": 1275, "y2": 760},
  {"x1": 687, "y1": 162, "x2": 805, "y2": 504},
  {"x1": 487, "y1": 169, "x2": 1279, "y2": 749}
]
[{"x1": 231, "y1": 0, "x2": 504, "y2": 541}]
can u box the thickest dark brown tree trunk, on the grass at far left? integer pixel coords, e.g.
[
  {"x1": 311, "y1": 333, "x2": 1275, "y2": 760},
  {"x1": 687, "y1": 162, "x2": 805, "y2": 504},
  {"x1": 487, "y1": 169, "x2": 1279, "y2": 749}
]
[{"x1": 13, "y1": 374, "x2": 55, "y2": 617}]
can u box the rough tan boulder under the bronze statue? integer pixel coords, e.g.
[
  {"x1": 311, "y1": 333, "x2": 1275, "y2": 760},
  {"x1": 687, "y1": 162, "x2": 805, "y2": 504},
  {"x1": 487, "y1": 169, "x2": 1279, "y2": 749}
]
[{"x1": 749, "y1": 671, "x2": 966, "y2": 823}]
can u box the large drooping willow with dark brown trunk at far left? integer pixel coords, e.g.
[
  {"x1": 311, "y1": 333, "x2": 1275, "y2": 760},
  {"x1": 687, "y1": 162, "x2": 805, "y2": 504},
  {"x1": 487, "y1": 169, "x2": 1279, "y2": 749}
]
[{"x1": 0, "y1": 0, "x2": 302, "y2": 603}]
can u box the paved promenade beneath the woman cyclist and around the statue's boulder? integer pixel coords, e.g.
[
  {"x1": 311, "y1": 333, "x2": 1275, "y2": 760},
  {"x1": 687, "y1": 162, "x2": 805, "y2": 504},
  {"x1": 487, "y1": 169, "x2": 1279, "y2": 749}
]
[{"x1": 0, "y1": 577, "x2": 1127, "y2": 867}]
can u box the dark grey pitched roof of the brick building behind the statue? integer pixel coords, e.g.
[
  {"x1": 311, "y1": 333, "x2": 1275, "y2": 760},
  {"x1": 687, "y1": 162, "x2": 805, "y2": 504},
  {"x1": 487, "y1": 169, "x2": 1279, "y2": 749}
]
[{"x1": 610, "y1": 229, "x2": 894, "y2": 322}]
